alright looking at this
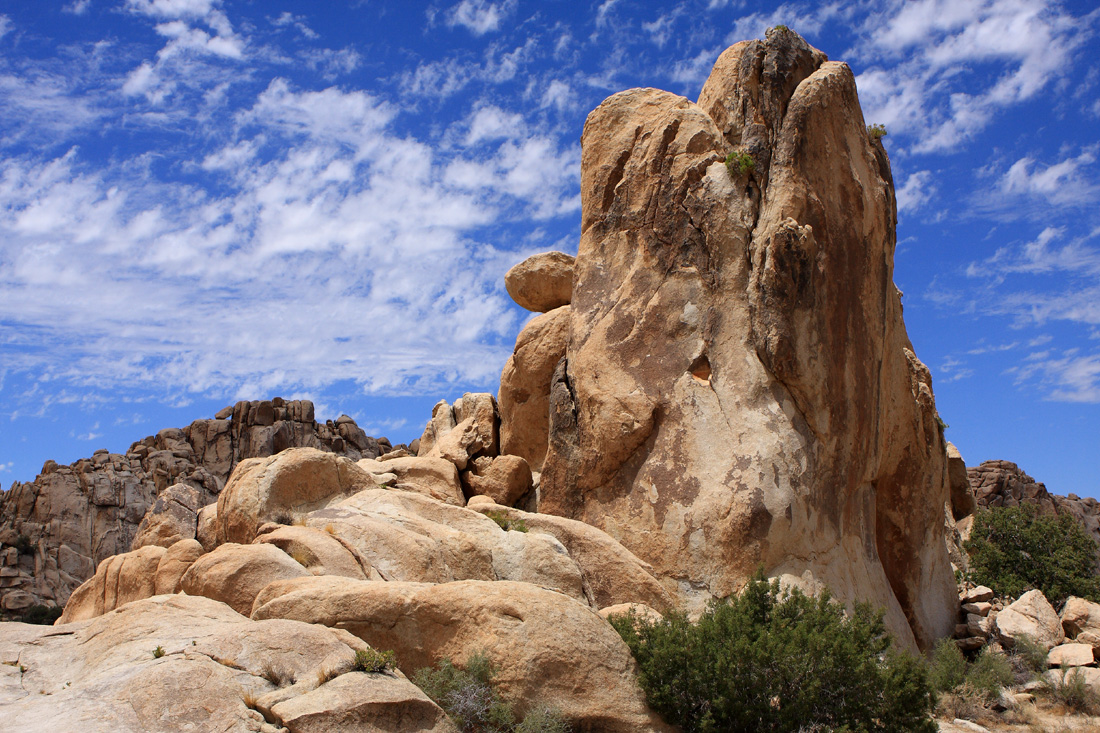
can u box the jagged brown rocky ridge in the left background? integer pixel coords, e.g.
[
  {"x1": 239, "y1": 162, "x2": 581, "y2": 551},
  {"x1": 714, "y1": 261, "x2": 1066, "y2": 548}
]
[{"x1": 0, "y1": 397, "x2": 392, "y2": 609}]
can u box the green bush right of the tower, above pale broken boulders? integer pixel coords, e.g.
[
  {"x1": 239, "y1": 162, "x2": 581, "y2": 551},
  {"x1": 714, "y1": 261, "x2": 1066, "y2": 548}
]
[{"x1": 963, "y1": 504, "x2": 1100, "y2": 608}]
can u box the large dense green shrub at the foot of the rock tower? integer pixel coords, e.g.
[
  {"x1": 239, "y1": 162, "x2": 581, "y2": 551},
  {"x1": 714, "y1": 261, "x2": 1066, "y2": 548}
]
[{"x1": 612, "y1": 572, "x2": 935, "y2": 732}]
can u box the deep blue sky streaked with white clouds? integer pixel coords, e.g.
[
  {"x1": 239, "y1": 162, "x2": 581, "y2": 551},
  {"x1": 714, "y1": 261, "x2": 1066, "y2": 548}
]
[{"x1": 0, "y1": 0, "x2": 1100, "y2": 496}]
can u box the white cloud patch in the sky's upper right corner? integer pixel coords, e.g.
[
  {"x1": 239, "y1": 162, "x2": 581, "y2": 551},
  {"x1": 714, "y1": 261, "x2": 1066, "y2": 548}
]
[{"x1": 857, "y1": 0, "x2": 1090, "y2": 152}]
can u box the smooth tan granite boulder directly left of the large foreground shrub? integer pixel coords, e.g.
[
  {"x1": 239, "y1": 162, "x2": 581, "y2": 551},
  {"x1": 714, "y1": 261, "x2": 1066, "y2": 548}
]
[{"x1": 253, "y1": 579, "x2": 671, "y2": 733}]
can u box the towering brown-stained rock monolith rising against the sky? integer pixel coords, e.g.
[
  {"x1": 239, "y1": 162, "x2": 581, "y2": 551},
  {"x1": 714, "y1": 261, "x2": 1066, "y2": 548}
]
[{"x1": 539, "y1": 31, "x2": 957, "y2": 646}]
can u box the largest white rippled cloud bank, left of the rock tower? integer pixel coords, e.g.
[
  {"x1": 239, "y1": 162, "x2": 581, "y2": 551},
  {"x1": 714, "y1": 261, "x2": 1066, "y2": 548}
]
[{"x1": 0, "y1": 67, "x2": 579, "y2": 402}]
